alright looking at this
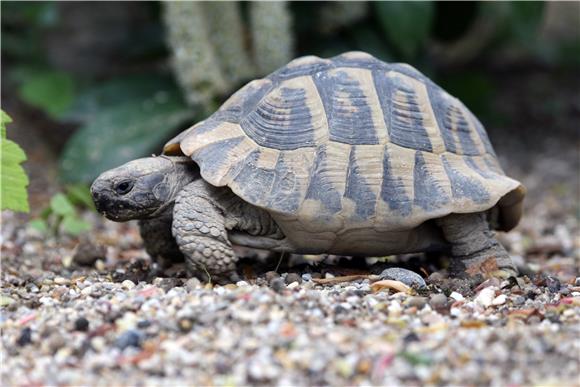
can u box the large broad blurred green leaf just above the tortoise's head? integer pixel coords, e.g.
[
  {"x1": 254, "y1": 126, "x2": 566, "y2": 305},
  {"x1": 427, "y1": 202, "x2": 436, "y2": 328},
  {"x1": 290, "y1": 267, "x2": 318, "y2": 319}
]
[{"x1": 60, "y1": 77, "x2": 193, "y2": 183}]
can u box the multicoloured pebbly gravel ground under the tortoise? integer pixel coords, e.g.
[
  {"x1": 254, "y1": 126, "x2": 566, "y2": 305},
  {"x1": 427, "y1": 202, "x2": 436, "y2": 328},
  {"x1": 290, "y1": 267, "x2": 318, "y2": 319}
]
[{"x1": 0, "y1": 145, "x2": 580, "y2": 386}]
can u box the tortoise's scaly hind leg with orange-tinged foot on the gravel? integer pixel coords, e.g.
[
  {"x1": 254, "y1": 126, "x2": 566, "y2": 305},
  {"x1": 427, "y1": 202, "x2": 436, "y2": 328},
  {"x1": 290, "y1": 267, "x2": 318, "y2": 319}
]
[{"x1": 437, "y1": 213, "x2": 518, "y2": 278}]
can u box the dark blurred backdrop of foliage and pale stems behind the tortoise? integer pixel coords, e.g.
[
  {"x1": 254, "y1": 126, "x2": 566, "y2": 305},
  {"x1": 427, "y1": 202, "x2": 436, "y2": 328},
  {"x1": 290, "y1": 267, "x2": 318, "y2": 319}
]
[{"x1": 1, "y1": 2, "x2": 580, "y2": 212}]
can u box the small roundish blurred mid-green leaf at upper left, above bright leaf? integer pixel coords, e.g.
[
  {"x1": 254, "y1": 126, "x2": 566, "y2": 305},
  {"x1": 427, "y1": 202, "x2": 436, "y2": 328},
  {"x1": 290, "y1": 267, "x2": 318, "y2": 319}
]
[{"x1": 18, "y1": 70, "x2": 74, "y2": 119}]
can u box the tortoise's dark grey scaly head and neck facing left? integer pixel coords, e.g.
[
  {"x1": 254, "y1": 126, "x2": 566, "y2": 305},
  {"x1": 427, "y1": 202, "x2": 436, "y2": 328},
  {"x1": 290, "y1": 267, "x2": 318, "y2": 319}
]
[{"x1": 91, "y1": 156, "x2": 199, "y2": 222}]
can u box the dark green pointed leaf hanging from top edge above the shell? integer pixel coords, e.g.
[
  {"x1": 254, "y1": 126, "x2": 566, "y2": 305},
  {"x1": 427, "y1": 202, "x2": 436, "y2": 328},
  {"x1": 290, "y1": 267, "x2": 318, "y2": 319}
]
[{"x1": 373, "y1": 1, "x2": 434, "y2": 59}]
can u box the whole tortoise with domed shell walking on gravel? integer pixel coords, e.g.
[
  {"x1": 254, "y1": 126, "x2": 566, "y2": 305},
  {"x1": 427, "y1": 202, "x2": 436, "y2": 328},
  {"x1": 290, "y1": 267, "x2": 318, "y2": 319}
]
[{"x1": 91, "y1": 52, "x2": 525, "y2": 280}]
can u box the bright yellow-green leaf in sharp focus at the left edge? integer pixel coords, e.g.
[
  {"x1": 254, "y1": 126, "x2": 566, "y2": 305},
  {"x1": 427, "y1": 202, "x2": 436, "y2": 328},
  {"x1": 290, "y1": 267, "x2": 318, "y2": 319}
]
[{"x1": 0, "y1": 111, "x2": 29, "y2": 212}]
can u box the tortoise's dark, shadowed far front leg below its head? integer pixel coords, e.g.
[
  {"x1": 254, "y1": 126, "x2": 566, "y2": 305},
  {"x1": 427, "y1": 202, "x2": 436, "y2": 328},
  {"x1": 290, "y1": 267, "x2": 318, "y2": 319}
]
[{"x1": 139, "y1": 210, "x2": 184, "y2": 266}]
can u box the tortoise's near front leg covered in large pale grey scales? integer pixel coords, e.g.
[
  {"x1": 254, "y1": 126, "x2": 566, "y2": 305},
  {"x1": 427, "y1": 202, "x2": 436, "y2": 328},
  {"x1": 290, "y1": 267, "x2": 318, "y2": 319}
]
[{"x1": 172, "y1": 180, "x2": 238, "y2": 282}]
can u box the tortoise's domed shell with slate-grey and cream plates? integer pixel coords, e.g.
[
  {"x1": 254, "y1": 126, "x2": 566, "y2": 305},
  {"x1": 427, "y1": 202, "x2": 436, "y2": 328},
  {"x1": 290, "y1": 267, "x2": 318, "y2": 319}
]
[{"x1": 164, "y1": 52, "x2": 524, "y2": 234}]
